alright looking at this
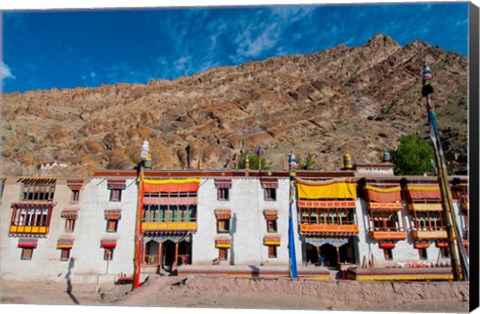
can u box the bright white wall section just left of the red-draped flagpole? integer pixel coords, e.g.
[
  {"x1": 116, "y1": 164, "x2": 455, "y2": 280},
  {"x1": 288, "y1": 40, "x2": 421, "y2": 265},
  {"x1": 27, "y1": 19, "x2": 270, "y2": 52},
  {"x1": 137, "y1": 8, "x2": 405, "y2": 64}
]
[{"x1": 71, "y1": 178, "x2": 138, "y2": 282}]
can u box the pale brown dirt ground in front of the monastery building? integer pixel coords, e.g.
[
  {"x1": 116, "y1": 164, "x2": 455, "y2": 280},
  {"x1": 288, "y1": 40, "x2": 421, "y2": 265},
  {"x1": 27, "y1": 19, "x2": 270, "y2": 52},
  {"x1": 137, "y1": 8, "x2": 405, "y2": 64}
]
[{"x1": 1, "y1": 276, "x2": 469, "y2": 313}]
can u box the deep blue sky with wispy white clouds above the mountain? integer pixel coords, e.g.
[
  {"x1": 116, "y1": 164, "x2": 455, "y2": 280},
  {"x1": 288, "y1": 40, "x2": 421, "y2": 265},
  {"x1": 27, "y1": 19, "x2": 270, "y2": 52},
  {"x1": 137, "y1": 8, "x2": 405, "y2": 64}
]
[{"x1": 1, "y1": 2, "x2": 468, "y2": 92}]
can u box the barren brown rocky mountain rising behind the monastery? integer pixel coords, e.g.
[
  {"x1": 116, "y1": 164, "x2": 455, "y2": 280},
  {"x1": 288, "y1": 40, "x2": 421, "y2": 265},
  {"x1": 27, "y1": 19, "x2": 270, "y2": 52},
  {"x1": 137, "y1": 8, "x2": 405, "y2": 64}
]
[{"x1": 2, "y1": 34, "x2": 468, "y2": 176}]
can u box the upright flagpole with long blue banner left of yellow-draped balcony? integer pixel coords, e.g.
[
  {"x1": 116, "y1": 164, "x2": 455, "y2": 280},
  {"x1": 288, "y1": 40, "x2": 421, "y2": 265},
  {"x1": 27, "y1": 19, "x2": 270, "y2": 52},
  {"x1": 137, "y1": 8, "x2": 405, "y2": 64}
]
[{"x1": 288, "y1": 152, "x2": 298, "y2": 279}]
